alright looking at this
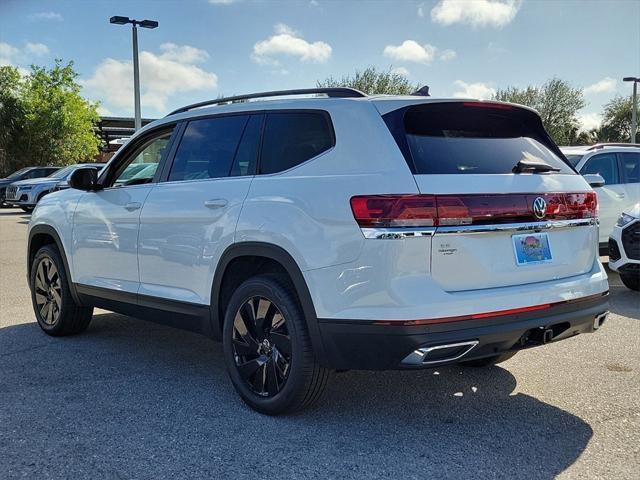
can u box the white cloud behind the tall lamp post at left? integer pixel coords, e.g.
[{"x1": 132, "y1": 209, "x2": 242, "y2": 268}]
[{"x1": 80, "y1": 43, "x2": 218, "y2": 112}]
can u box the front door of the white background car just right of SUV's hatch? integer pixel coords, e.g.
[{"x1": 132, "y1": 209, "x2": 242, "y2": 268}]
[{"x1": 580, "y1": 152, "x2": 627, "y2": 243}]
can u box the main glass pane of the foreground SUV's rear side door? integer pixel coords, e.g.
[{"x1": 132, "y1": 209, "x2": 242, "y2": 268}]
[{"x1": 169, "y1": 115, "x2": 249, "y2": 182}]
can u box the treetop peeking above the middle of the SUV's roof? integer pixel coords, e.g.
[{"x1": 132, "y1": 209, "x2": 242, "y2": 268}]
[{"x1": 317, "y1": 67, "x2": 420, "y2": 95}]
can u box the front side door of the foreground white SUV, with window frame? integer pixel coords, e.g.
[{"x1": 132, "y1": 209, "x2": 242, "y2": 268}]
[{"x1": 72, "y1": 126, "x2": 174, "y2": 294}]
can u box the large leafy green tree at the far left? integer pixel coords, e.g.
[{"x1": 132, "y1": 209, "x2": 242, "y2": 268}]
[{"x1": 0, "y1": 60, "x2": 100, "y2": 174}]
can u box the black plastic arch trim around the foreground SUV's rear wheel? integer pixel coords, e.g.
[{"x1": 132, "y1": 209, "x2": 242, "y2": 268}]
[{"x1": 211, "y1": 242, "x2": 326, "y2": 364}]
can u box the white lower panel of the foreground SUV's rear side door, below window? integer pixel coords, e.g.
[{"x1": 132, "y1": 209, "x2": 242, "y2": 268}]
[{"x1": 138, "y1": 177, "x2": 252, "y2": 304}]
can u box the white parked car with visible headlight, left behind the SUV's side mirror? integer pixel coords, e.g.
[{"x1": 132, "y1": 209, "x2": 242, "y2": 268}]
[{"x1": 5, "y1": 163, "x2": 103, "y2": 212}]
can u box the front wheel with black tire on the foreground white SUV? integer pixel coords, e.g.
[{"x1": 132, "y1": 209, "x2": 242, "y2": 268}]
[{"x1": 29, "y1": 245, "x2": 93, "y2": 337}]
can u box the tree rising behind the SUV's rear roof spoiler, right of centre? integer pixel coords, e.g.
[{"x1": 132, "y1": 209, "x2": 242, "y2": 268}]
[{"x1": 494, "y1": 78, "x2": 585, "y2": 145}]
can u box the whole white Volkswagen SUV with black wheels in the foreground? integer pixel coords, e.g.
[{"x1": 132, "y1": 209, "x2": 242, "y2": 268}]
[{"x1": 28, "y1": 88, "x2": 608, "y2": 414}]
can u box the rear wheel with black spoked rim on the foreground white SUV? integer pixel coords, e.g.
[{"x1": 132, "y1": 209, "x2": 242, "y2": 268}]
[{"x1": 223, "y1": 275, "x2": 330, "y2": 415}]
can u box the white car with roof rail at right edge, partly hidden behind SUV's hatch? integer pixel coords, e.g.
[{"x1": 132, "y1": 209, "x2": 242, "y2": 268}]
[{"x1": 560, "y1": 143, "x2": 640, "y2": 250}]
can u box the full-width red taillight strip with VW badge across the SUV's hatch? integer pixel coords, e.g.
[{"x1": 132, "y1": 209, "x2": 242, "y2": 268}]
[{"x1": 351, "y1": 192, "x2": 598, "y2": 228}]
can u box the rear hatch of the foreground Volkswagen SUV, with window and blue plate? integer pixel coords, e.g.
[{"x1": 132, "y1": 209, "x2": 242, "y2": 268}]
[{"x1": 384, "y1": 101, "x2": 598, "y2": 291}]
